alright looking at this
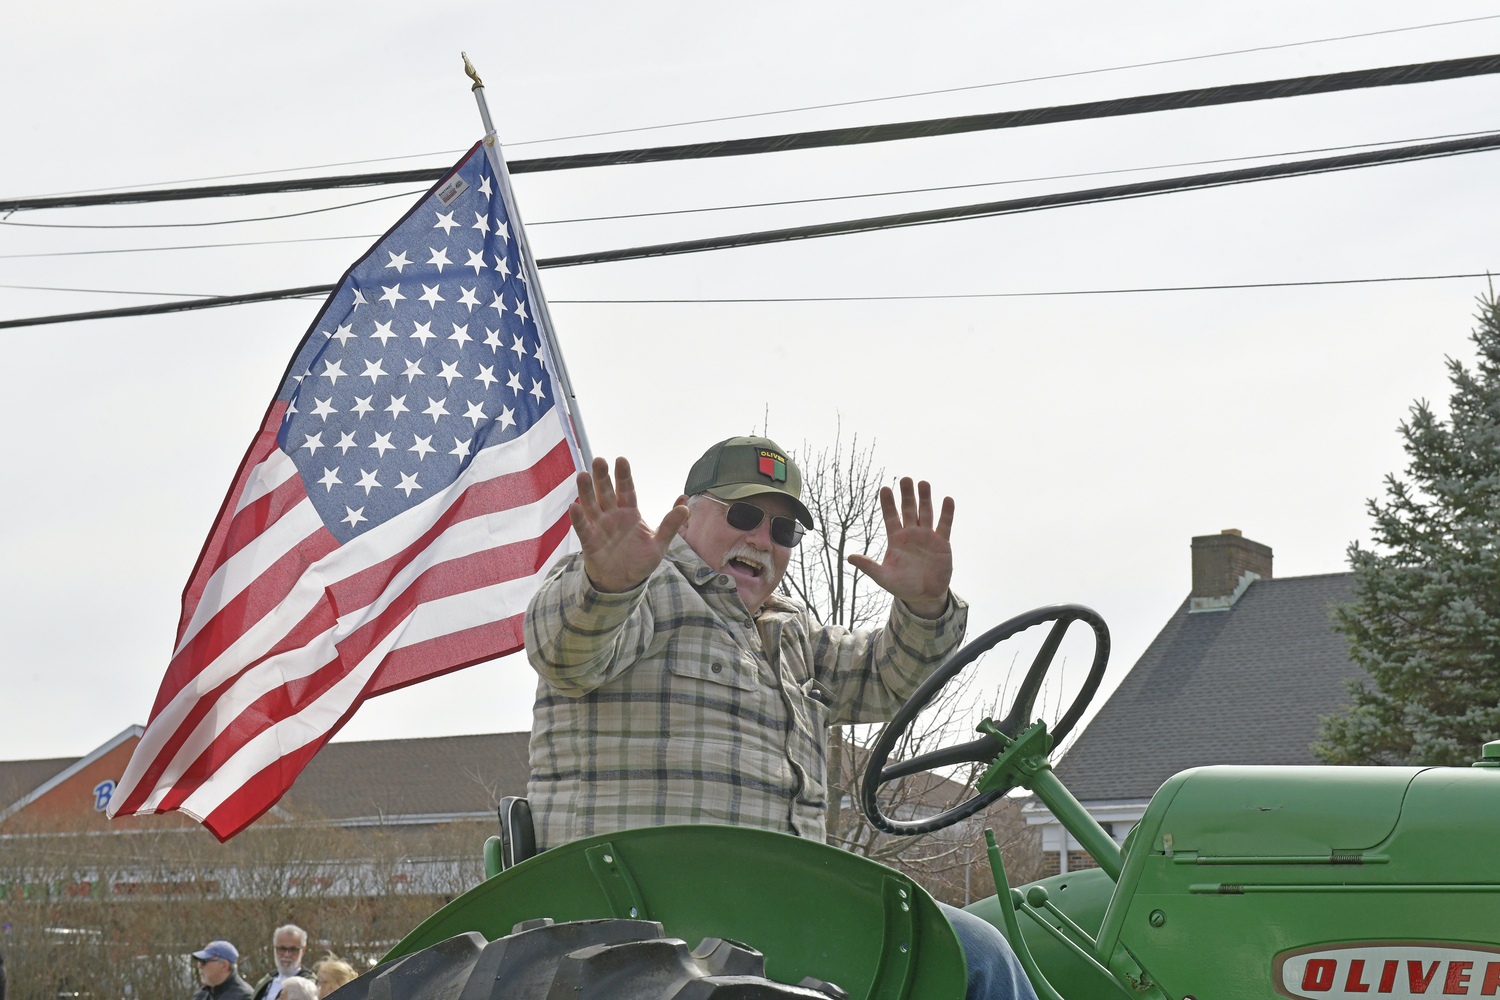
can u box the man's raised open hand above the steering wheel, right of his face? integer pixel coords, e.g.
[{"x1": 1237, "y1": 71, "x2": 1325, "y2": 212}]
[{"x1": 849, "y1": 478, "x2": 953, "y2": 618}]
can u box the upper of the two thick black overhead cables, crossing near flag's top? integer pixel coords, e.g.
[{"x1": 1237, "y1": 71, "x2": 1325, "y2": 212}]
[{"x1": 0, "y1": 55, "x2": 1500, "y2": 211}]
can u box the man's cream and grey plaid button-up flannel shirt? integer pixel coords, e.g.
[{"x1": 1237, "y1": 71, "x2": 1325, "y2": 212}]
[{"x1": 525, "y1": 538, "x2": 968, "y2": 849}]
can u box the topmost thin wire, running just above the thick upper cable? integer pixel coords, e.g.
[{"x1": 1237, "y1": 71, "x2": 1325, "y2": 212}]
[{"x1": 8, "y1": 13, "x2": 1500, "y2": 198}]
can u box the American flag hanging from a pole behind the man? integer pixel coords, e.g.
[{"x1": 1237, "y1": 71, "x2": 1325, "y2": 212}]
[{"x1": 110, "y1": 142, "x2": 582, "y2": 840}]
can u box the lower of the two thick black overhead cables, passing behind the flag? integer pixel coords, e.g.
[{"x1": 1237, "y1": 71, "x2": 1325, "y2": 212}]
[{"x1": 0, "y1": 128, "x2": 1500, "y2": 330}]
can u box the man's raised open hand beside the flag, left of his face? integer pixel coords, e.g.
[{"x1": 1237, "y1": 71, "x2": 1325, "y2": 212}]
[{"x1": 567, "y1": 457, "x2": 687, "y2": 594}]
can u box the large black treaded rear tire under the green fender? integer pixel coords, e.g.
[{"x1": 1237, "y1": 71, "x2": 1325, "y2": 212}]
[{"x1": 338, "y1": 918, "x2": 849, "y2": 1000}]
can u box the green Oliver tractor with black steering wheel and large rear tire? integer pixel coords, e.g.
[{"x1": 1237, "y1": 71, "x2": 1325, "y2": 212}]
[{"x1": 339, "y1": 606, "x2": 1500, "y2": 1000}]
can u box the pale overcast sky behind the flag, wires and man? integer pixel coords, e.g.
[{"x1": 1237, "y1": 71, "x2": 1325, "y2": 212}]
[{"x1": 0, "y1": 0, "x2": 1500, "y2": 759}]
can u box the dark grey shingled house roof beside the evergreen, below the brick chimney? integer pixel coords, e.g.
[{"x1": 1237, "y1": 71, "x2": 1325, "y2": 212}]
[{"x1": 1056, "y1": 573, "x2": 1361, "y2": 802}]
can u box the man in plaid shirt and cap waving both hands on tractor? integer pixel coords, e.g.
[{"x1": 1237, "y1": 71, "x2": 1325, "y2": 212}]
[{"x1": 525, "y1": 438, "x2": 1035, "y2": 999}]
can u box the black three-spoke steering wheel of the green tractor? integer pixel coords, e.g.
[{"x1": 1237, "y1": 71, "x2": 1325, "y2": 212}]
[{"x1": 860, "y1": 604, "x2": 1110, "y2": 837}]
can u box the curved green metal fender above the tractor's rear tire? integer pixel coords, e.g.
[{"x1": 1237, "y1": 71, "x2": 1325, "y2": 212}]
[{"x1": 386, "y1": 826, "x2": 966, "y2": 1000}]
